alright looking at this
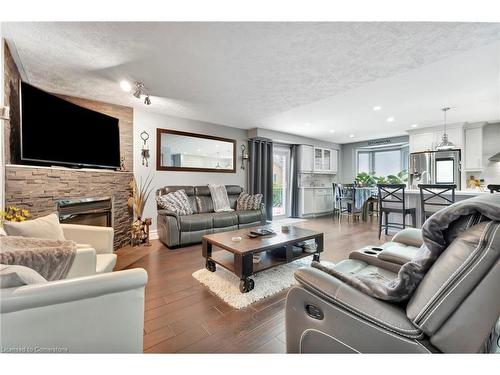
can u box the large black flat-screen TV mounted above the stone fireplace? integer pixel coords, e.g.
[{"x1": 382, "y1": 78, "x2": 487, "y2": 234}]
[{"x1": 21, "y1": 82, "x2": 120, "y2": 169}]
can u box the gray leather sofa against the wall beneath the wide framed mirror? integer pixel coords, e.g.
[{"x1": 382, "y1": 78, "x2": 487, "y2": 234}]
[{"x1": 156, "y1": 185, "x2": 266, "y2": 248}]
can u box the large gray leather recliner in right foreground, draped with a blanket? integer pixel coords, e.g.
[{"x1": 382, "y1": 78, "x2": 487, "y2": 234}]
[{"x1": 286, "y1": 222, "x2": 500, "y2": 353}]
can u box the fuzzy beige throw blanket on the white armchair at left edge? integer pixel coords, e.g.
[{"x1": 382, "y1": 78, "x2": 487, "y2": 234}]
[{"x1": 0, "y1": 236, "x2": 76, "y2": 281}]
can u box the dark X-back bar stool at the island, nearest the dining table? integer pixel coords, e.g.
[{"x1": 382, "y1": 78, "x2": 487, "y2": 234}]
[{"x1": 377, "y1": 184, "x2": 417, "y2": 239}]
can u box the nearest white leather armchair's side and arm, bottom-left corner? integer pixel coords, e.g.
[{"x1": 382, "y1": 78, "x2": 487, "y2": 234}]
[{"x1": 0, "y1": 268, "x2": 147, "y2": 353}]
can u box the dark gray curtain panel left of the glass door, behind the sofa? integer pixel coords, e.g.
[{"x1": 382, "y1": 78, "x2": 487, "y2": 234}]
[{"x1": 248, "y1": 138, "x2": 273, "y2": 220}]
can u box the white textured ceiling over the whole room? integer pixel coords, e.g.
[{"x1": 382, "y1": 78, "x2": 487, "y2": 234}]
[{"x1": 2, "y1": 22, "x2": 500, "y2": 142}]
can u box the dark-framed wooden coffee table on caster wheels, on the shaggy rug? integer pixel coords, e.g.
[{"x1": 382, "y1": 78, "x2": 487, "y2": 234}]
[{"x1": 202, "y1": 224, "x2": 323, "y2": 293}]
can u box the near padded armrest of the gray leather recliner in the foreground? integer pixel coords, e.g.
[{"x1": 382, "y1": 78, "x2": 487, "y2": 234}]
[{"x1": 295, "y1": 268, "x2": 422, "y2": 338}]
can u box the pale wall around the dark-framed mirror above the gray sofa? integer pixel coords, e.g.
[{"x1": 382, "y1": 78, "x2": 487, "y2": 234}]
[{"x1": 134, "y1": 109, "x2": 248, "y2": 231}]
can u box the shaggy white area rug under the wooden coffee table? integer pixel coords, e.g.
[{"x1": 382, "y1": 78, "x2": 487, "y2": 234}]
[{"x1": 193, "y1": 254, "x2": 312, "y2": 309}]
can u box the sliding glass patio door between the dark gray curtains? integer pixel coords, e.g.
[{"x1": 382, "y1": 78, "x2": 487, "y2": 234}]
[{"x1": 273, "y1": 145, "x2": 290, "y2": 219}]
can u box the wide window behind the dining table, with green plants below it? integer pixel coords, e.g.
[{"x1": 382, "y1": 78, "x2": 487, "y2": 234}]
[{"x1": 357, "y1": 146, "x2": 408, "y2": 176}]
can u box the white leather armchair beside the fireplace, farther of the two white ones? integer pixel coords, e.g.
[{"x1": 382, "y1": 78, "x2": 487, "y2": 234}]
[{"x1": 61, "y1": 224, "x2": 116, "y2": 279}]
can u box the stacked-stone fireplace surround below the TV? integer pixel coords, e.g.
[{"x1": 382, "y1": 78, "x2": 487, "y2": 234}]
[{"x1": 5, "y1": 165, "x2": 133, "y2": 250}]
